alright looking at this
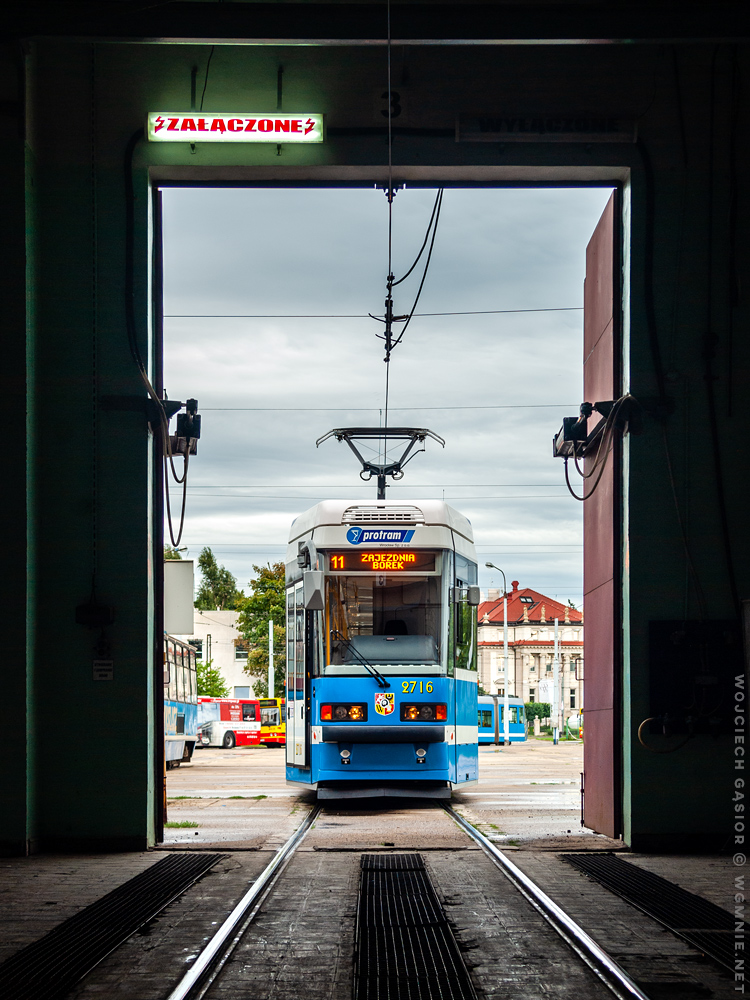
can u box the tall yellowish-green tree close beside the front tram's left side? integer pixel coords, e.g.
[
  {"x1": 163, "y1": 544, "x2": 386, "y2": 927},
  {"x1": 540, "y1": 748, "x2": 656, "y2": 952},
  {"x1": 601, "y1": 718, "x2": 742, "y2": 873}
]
[{"x1": 237, "y1": 562, "x2": 286, "y2": 698}]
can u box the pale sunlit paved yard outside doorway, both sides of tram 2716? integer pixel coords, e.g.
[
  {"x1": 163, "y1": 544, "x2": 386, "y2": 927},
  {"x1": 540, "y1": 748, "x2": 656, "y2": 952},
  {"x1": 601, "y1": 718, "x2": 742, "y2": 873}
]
[{"x1": 165, "y1": 739, "x2": 619, "y2": 850}]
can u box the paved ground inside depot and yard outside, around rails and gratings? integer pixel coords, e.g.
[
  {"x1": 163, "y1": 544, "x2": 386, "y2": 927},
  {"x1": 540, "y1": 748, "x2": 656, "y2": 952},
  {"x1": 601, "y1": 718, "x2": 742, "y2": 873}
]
[{"x1": 0, "y1": 740, "x2": 736, "y2": 1000}]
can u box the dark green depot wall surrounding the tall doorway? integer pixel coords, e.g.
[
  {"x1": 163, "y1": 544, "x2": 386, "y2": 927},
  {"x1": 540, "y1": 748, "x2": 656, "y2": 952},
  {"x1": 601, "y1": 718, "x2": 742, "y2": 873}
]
[{"x1": 0, "y1": 35, "x2": 750, "y2": 852}]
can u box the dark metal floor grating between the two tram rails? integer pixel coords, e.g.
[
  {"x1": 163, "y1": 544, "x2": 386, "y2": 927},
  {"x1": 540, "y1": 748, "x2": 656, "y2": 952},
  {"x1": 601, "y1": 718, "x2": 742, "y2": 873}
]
[{"x1": 354, "y1": 854, "x2": 476, "y2": 1000}]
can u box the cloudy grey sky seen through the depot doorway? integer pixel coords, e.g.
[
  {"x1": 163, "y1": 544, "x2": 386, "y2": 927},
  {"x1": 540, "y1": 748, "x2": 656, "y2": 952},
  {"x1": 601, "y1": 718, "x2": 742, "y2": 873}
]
[{"x1": 164, "y1": 188, "x2": 610, "y2": 604}]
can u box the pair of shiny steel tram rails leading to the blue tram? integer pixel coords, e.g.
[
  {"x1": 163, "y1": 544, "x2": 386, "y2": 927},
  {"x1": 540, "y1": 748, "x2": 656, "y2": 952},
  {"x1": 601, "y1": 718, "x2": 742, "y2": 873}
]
[{"x1": 167, "y1": 803, "x2": 650, "y2": 1000}]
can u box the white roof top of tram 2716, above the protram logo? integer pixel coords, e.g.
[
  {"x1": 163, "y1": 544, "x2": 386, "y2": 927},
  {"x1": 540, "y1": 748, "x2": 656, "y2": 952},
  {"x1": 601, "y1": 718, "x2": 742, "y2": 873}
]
[{"x1": 289, "y1": 500, "x2": 474, "y2": 542}]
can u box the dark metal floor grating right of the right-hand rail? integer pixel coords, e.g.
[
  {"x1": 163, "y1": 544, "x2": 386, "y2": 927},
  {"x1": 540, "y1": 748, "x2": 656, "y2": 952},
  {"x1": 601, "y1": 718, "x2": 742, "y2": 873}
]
[{"x1": 561, "y1": 854, "x2": 750, "y2": 971}]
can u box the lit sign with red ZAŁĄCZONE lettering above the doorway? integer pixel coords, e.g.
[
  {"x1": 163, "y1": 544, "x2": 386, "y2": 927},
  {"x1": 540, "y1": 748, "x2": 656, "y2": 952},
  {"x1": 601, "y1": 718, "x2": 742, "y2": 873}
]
[{"x1": 146, "y1": 111, "x2": 324, "y2": 142}]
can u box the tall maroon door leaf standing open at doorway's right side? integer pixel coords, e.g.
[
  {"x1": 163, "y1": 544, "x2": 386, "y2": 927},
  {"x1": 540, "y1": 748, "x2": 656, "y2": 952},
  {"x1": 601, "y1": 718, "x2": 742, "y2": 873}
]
[{"x1": 583, "y1": 192, "x2": 622, "y2": 837}]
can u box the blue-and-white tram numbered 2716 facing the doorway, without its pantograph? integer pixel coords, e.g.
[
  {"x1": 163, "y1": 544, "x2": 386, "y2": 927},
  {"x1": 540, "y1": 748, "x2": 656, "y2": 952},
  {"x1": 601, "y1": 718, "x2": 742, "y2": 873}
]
[{"x1": 286, "y1": 500, "x2": 479, "y2": 799}]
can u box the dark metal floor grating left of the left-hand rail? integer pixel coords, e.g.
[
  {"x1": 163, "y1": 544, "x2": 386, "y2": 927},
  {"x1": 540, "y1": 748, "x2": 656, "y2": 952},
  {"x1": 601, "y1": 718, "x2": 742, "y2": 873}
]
[{"x1": 0, "y1": 853, "x2": 226, "y2": 1000}]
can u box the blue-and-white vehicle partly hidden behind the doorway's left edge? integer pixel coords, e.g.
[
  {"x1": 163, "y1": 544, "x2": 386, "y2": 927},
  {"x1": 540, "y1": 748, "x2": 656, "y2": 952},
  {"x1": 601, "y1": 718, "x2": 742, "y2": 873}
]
[{"x1": 164, "y1": 634, "x2": 198, "y2": 770}]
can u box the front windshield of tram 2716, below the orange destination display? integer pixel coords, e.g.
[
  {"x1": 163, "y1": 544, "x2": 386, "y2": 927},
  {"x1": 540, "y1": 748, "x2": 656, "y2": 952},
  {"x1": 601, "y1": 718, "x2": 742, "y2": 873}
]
[{"x1": 326, "y1": 560, "x2": 442, "y2": 673}]
